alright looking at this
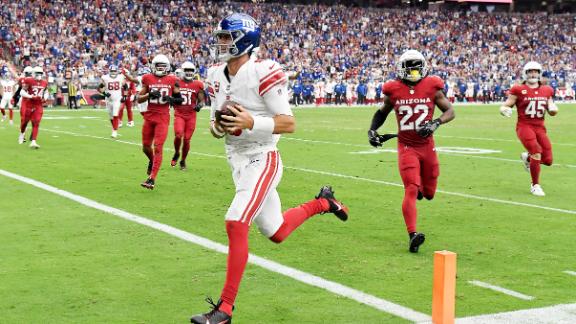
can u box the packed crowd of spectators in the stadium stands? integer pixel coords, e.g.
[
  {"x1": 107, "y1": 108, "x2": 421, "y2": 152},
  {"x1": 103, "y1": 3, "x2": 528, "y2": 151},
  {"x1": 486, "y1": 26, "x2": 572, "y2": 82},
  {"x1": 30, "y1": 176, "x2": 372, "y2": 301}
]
[{"x1": 0, "y1": 0, "x2": 576, "y2": 103}]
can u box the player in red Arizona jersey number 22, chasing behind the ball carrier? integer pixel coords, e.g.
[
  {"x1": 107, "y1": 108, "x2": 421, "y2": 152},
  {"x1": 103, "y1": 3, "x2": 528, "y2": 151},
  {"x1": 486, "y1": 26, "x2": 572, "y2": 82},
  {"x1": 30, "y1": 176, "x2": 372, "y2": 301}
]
[{"x1": 368, "y1": 50, "x2": 454, "y2": 253}]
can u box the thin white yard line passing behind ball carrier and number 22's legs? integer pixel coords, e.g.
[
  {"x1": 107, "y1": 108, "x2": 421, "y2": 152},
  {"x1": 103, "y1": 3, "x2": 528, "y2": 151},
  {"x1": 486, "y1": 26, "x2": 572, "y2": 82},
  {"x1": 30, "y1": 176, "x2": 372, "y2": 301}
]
[{"x1": 43, "y1": 129, "x2": 576, "y2": 215}]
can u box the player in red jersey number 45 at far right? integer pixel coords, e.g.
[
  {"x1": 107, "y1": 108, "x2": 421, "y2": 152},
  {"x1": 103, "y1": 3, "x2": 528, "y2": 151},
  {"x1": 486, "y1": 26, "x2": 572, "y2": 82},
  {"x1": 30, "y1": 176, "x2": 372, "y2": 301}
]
[{"x1": 500, "y1": 62, "x2": 558, "y2": 196}]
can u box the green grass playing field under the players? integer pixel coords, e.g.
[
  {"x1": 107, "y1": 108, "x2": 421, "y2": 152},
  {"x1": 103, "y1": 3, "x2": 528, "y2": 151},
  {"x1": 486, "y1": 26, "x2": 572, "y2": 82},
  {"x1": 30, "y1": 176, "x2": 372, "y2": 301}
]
[{"x1": 0, "y1": 105, "x2": 576, "y2": 323}]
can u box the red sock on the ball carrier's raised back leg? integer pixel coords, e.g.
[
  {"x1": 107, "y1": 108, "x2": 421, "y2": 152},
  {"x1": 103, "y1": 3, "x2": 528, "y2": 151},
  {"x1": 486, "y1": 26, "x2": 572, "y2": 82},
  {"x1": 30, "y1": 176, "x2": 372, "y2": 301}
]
[{"x1": 270, "y1": 199, "x2": 330, "y2": 243}]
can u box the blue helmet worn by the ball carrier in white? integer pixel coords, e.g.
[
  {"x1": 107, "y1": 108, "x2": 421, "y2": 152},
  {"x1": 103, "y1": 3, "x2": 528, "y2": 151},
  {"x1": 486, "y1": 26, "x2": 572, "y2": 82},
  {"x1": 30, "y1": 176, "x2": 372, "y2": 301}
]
[{"x1": 210, "y1": 13, "x2": 261, "y2": 62}]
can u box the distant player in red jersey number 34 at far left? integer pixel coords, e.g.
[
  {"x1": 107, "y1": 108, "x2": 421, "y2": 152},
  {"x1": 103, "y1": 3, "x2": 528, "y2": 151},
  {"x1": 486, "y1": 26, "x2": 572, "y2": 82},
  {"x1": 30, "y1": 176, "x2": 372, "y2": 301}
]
[{"x1": 18, "y1": 66, "x2": 48, "y2": 149}]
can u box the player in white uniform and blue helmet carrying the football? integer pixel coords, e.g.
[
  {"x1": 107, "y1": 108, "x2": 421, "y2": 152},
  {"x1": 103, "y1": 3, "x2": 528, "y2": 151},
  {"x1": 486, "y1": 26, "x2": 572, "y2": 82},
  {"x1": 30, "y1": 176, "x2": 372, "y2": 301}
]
[{"x1": 191, "y1": 13, "x2": 348, "y2": 324}]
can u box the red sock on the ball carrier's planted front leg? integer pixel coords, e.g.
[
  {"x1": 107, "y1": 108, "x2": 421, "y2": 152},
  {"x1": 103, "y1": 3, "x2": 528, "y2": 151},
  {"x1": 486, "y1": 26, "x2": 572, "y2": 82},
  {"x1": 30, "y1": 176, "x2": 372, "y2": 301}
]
[{"x1": 220, "y1": 221, "x2": 249, "y2": 315}]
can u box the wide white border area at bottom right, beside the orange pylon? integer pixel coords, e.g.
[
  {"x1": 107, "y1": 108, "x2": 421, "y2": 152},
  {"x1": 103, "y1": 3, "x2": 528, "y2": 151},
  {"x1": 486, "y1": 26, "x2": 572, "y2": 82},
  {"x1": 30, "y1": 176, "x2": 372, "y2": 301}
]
[{"x1": 456, "y1": 304, "x2": 576, "y2": 324}]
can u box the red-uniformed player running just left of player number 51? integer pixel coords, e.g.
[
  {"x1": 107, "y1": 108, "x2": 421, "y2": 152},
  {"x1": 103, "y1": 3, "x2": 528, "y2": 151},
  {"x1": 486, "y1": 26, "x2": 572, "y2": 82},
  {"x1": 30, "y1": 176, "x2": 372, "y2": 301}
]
[{"x1": 138, "y1": 54, "x2": 184, "y2": 189}]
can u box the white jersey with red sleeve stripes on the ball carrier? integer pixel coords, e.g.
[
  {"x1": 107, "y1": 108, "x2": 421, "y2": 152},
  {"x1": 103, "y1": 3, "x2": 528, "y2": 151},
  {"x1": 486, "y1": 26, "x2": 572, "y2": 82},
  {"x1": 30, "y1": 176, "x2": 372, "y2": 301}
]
[{"x1": 206, "y1": 58, "x2": 292, "y2": 154}]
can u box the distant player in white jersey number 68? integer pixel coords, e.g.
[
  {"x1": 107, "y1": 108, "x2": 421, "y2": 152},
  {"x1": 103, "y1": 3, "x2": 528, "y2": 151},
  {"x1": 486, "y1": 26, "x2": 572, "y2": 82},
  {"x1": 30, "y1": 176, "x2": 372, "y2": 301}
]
[{"x1": 98, "y1": 65, "x2": 137, "y2": 138}]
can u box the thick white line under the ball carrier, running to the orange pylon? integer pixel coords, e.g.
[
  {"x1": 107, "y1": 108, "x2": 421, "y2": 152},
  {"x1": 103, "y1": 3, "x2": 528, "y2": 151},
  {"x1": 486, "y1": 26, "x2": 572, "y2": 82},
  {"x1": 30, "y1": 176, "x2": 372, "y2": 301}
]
[{"x1": 0, "y1": 169, "x2": 430, "y2": 321}]
